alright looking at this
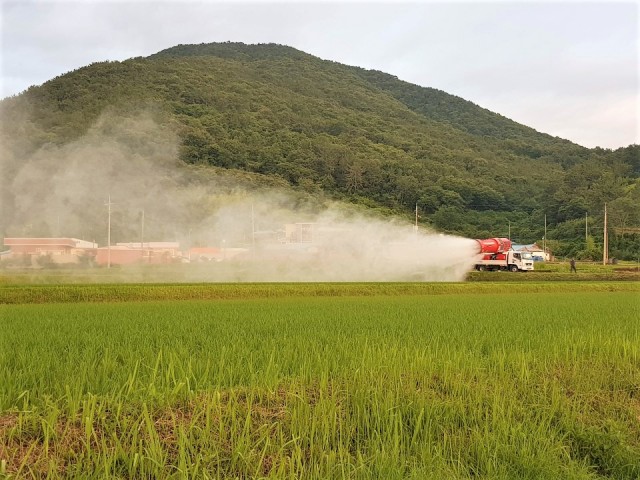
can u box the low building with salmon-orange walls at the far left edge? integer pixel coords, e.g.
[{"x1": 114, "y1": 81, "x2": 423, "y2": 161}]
[{"x1": 3, "y1": 238, "x2": 98, "y2": 264}]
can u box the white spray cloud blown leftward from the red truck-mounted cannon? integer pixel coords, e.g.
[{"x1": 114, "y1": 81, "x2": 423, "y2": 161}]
[{"x1": 0, "y1": 114, "x2": 476, "y2": 282}]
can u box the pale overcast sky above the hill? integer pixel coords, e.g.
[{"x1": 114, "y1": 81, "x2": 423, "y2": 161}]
[{"x1": 0, "y1": 0, "x2": 640, "y2": 148}]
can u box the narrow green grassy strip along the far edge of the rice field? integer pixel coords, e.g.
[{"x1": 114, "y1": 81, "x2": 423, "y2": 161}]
[{"x1": 0, "y1": 282, "x2": 640, "y2": 304}]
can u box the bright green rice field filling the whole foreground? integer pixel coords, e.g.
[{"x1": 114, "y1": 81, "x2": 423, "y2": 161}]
[{"x1": 0, "y1": 281, "x2": 640, "y2": 479}]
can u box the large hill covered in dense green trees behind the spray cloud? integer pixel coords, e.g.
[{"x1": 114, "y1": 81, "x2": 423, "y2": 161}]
[{"x1": 0, "y1": 43, "x2": 640, "y2": 257}]
